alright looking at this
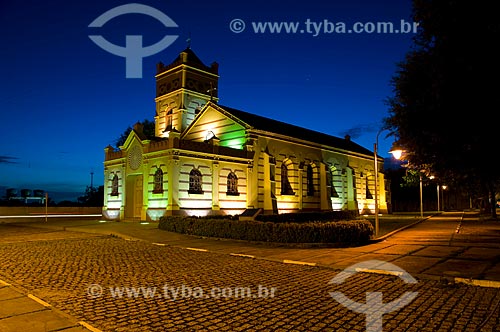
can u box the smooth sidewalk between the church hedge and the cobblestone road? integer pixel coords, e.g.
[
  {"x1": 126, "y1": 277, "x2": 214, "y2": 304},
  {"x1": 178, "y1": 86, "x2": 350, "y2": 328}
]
[{"x1": 10, "y1": 211, "x2": 500, "y2": 287}]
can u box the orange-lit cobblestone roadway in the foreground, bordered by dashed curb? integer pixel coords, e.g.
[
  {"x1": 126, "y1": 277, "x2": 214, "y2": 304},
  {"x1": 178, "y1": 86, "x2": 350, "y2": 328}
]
[{"x1": 0, "y1": 226, "x2": 500, "y2": 332}]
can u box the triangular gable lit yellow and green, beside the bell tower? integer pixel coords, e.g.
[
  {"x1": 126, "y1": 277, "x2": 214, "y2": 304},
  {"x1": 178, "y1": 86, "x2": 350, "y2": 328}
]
[{"x1": 181, "y1": 102, "x2": 252, "y2": 149}]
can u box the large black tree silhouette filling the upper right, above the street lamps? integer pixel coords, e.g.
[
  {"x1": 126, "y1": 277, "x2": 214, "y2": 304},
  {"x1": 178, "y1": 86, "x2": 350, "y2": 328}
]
[{"x1": 386, "y1": 0, "x2": 500, "y2": 218}]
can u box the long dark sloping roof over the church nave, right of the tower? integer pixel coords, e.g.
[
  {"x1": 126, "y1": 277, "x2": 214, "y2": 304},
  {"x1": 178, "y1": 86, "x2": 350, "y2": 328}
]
[{"x1": 217, "y1": 105, "x2": 373, "y2": 156}]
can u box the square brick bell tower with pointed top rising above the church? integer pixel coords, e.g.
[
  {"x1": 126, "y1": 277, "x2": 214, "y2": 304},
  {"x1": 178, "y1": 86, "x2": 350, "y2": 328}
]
[{"x1": 155, "y1": 47, "x2": 219, "y2": 137}]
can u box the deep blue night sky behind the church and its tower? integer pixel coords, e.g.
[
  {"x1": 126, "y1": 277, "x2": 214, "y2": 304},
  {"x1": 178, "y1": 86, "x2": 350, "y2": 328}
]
[{"x1": 0, "y1": 0, "x2": 414, "y2": 200}]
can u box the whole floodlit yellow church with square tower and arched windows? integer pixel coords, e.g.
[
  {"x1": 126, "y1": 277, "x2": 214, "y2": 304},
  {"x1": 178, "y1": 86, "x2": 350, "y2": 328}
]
[{"x1": 103, "y1": 48, "x2": 388, "y2": 221}]
